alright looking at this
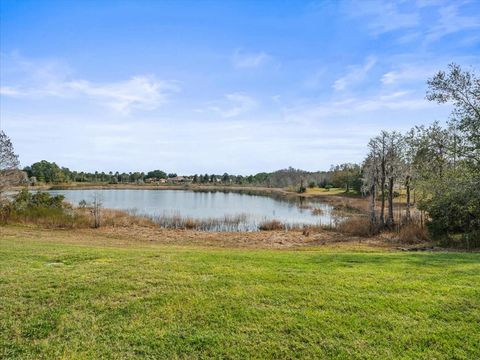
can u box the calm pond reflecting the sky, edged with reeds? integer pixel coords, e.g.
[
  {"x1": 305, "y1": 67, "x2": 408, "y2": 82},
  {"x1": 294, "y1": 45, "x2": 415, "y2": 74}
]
[{"x1": 49, "y1": 189, "x2": 338, "y2": 231}]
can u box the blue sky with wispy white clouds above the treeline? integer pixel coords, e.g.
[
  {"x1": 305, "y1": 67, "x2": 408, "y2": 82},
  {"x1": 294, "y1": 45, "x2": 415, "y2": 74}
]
[{"x1": 0, "y1": 0, "x2": 480, "y2": 174}]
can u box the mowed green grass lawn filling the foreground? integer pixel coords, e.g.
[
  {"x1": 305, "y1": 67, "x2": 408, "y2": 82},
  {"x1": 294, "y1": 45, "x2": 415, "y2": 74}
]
[{"x1": 0, "y1": 229, "x2": 480, "y2": 359}]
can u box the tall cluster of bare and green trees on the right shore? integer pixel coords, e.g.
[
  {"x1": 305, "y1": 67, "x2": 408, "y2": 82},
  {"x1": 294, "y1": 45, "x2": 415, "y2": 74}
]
[{"x1": 362, "y1": 64, "x2": 480, "y2": 245}]
